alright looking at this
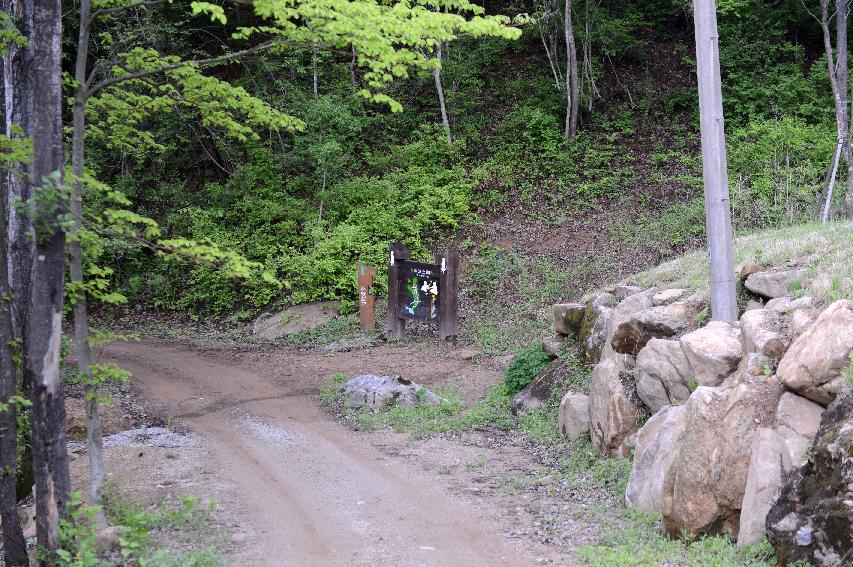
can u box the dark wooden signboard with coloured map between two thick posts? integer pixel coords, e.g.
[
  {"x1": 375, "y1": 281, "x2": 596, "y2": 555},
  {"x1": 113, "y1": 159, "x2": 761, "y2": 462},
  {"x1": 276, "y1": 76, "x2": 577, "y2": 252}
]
[{"x1": 388, "y1": 244, "x2": 459, "y2": 345}]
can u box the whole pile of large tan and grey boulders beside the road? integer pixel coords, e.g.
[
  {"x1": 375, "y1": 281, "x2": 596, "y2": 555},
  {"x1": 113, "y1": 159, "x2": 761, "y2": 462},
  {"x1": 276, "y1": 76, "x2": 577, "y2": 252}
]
[{"x1": 552, "y1": 276, "x2": 853, "y2": 565}]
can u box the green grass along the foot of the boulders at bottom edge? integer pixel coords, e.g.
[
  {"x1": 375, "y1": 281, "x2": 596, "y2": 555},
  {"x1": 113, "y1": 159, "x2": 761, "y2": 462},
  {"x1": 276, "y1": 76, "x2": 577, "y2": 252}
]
[{"x1": 577, "y1": 509, "x2": 774, "y2": 567}]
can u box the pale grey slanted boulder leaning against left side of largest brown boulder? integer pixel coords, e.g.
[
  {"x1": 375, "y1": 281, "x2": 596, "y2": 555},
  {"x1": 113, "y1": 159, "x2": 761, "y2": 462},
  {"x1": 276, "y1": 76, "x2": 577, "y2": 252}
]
[{"x1": 625, "y1": 406, "x2": 686, "y2": 514}]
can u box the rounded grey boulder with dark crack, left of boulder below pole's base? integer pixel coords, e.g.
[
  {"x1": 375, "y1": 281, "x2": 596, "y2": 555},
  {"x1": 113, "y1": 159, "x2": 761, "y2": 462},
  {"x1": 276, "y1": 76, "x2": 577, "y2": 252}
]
[{"x1": 634, "y1": 339, "x2": 692, "y2": 412}]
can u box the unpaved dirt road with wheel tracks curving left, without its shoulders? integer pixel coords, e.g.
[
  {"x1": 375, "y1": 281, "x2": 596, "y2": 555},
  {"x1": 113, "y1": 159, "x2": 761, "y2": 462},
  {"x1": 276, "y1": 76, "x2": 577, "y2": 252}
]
[{"x1": 106, "y1": 343, "x2": 532, "y2": 566}]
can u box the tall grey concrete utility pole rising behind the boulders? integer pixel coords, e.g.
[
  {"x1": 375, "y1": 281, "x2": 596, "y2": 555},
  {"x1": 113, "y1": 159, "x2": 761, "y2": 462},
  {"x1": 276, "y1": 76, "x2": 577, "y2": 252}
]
[{"x1": 693, "y1": 0, "x2": 737, "y2": 323}]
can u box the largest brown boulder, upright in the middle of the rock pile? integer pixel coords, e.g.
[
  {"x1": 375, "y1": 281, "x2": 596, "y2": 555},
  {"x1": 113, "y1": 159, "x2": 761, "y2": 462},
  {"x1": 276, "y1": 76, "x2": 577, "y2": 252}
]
[{"x1": 661, "y1": 374, "x2": 782, "y2": 537}]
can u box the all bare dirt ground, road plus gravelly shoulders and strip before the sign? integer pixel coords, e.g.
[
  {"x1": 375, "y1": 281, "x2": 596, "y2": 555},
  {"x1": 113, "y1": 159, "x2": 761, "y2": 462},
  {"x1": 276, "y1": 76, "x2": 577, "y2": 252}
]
[{"x1": 101, "y1": 342, "x2": 575, "y2": 565}]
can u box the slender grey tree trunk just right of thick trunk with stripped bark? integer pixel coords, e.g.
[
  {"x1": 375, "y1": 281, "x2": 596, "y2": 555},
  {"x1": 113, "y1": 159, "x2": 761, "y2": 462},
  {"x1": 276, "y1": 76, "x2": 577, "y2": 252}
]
[{"x1": 69, "y1": 0, "x2": 106, "y2": 527}]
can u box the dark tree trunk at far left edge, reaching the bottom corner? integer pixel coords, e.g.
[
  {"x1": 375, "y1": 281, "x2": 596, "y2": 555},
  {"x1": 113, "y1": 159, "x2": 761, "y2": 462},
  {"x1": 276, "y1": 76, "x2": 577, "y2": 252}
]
[{"x1": 0, "y1": 130, "x2": 29, "y2": 567}]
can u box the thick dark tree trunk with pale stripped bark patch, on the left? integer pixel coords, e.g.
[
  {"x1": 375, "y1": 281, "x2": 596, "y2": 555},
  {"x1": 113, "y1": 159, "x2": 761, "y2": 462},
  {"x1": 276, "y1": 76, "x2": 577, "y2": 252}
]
[{"x1": 24, "y1": 0, "x2": 71, "y2": 561}]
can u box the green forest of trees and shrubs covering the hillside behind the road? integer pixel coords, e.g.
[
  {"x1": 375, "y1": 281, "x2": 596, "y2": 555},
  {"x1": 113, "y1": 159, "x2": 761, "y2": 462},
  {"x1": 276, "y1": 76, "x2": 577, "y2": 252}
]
[{"x1": 0, "y1": 0, "x2": 853, "y2": 566}]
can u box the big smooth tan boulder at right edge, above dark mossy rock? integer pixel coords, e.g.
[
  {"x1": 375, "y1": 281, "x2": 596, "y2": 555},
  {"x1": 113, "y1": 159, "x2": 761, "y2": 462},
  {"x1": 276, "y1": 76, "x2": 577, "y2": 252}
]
[{"x1": 776, "y1": 299, "x2": 853, "y2": 405}]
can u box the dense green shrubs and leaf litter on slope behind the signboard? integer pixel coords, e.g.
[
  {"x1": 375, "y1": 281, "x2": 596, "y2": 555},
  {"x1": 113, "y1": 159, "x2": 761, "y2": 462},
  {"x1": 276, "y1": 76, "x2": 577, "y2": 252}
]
[{"x1": 88, "y1": 0, "x2": 844, "y2": 326}]
